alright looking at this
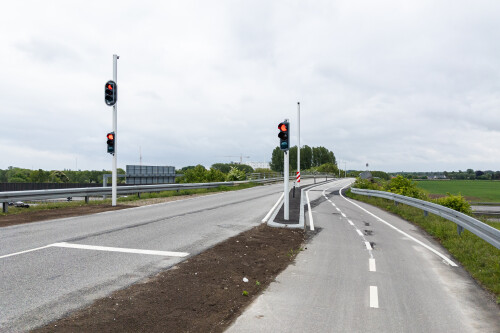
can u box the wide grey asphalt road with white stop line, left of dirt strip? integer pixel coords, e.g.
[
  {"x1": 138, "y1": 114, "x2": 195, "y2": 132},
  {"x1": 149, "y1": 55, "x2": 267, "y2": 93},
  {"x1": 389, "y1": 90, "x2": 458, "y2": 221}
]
[{"x1": 0, "y1": 180, "x2": 312, "y2": 332}]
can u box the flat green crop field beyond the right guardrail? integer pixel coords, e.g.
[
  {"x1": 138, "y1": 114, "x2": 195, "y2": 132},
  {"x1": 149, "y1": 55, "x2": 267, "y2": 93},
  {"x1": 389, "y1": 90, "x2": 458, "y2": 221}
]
[{"x1": 416, "y1": 180, "x2": 500, "y2": 202}]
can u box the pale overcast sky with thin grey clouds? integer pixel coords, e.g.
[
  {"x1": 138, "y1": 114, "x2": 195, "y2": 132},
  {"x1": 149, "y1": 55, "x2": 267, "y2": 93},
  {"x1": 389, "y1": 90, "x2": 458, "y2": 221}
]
[{"x1": 0, "y1": 0, "x2": 500, "y2": 171}]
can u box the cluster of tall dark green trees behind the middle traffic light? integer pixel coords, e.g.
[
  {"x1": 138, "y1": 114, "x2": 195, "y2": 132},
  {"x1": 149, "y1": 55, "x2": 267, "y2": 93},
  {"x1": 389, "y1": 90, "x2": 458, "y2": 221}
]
[{"x1": 271, "y1": 145, "x2": 338, "y2": 173}]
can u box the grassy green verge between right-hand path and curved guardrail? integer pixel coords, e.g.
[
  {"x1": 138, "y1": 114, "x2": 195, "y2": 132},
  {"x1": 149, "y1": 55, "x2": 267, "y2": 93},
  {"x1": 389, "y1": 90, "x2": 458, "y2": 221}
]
[{"x1": 347, "y1": 191, "x2": 500, "y2": 304}]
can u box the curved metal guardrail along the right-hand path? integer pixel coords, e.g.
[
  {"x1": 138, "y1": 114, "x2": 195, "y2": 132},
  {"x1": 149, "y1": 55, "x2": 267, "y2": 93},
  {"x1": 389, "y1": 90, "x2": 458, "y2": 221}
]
[{"x1": 351, "y1": 187, "x2": 500, "y2": 249}]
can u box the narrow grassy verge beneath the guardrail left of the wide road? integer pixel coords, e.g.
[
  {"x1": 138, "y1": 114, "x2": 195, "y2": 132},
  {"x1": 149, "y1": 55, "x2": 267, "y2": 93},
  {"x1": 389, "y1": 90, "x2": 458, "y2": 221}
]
[{"x1": 0, "y1": 183, "x2": 259, "y2": 216}]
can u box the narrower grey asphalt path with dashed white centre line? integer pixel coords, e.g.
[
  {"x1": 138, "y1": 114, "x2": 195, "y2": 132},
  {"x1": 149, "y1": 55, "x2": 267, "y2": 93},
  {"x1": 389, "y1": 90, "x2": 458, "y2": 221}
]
[{"x1": 227, "y1": 180, "x2": 500, "y2": 333}]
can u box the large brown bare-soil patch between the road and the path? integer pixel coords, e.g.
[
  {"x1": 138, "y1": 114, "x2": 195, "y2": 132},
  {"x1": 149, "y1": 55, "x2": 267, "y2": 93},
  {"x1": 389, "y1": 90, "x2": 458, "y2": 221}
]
[{"x1": 33, "y1": 225, "x2": 305, "y2": 333}]
